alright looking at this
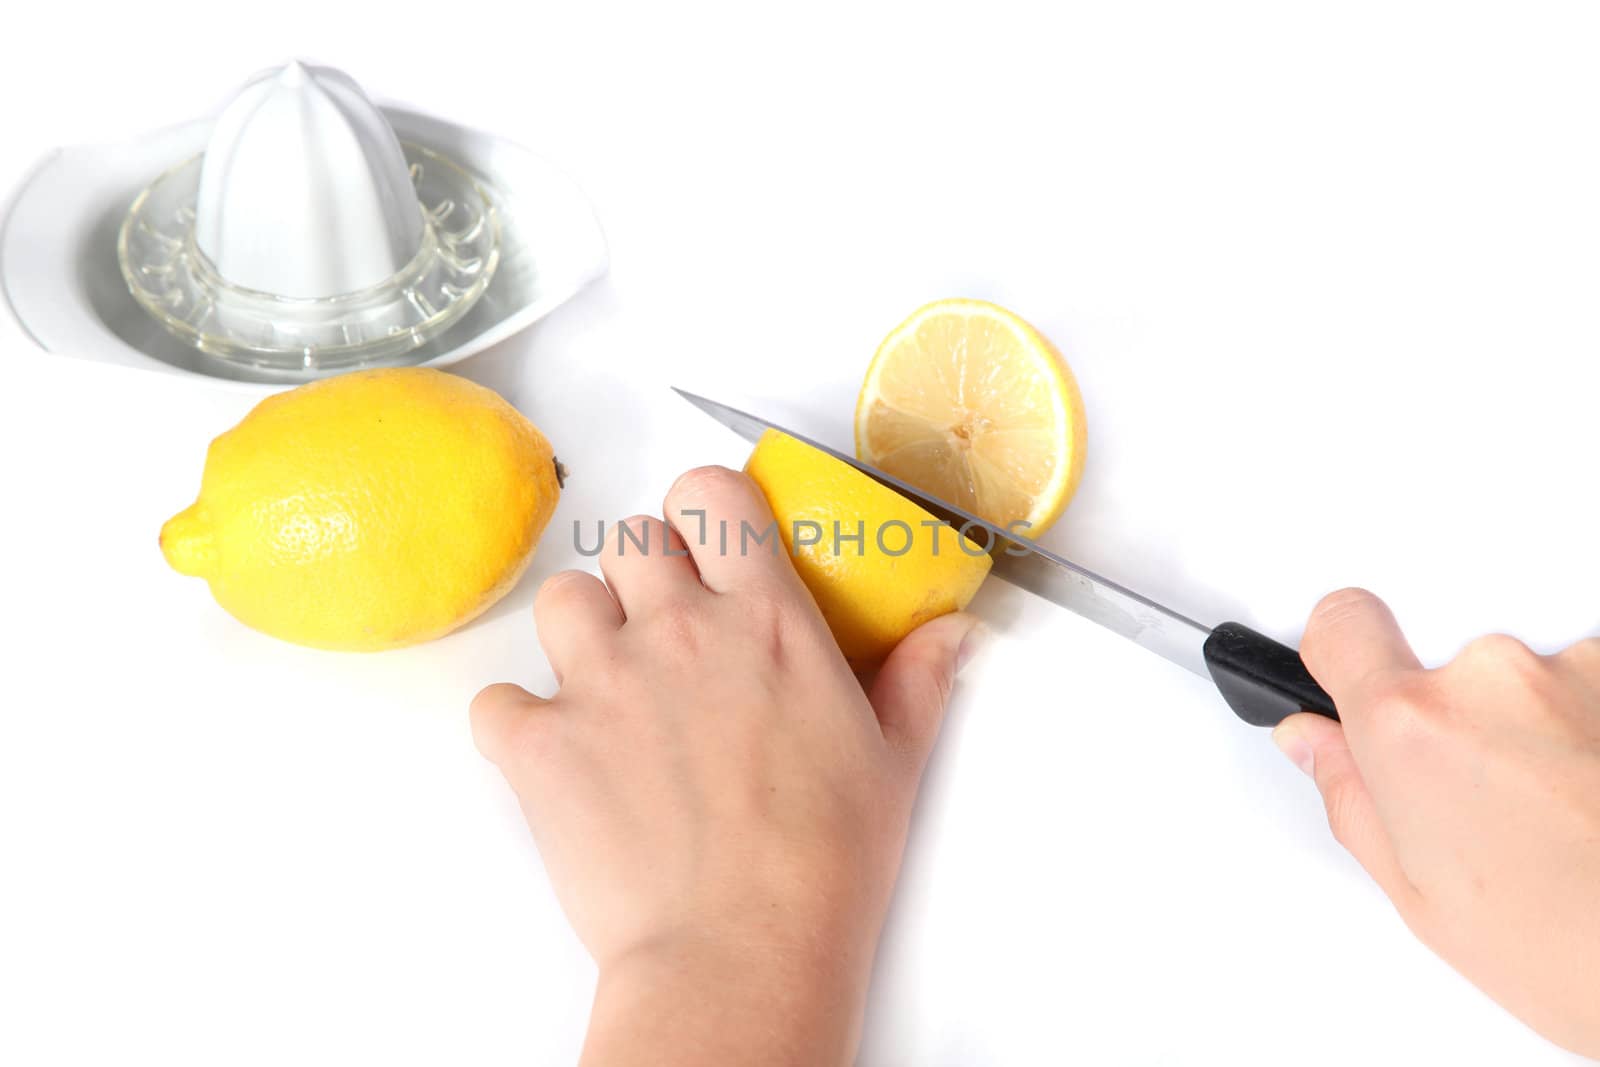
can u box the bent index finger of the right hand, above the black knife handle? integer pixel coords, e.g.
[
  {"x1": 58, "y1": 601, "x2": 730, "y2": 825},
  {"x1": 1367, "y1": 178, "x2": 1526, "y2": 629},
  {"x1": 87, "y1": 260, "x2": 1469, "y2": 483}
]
[{"x1": 1301, "y1": 589, "x2": 1422, "y2": 712}]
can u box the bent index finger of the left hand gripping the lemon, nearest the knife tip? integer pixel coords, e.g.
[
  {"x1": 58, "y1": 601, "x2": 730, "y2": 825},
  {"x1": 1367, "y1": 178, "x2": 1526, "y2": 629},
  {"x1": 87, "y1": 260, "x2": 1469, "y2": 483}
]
[{"x1": 662, "y1": 467, "x2": 800, "y2": 593}]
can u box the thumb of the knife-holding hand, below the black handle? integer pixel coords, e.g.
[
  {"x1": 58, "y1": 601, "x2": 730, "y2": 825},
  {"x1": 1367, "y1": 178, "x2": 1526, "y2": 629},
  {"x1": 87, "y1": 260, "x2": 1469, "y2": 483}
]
[{"x1": 1272, "y1": 713, "x2": 1416, "y2": 913}]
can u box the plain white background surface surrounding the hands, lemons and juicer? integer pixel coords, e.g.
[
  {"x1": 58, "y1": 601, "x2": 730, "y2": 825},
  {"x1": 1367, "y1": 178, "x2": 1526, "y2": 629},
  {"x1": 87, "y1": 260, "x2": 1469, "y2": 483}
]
[{"x1": 0, "y1": 0, "x2": 1600, "y2": 1067}]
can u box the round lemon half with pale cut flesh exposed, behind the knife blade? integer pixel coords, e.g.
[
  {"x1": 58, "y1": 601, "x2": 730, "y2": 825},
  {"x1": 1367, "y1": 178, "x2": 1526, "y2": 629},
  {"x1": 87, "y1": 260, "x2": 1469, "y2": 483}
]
[{"x1": 856, "y1": 299, "x2": 1085, "y2": 537}]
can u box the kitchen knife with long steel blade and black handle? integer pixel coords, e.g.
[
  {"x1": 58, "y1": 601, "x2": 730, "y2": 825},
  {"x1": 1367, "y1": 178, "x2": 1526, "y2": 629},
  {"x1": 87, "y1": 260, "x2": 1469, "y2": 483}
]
[{"x1": 674, "y1": 387, "x2": 1339, "y2": 726}]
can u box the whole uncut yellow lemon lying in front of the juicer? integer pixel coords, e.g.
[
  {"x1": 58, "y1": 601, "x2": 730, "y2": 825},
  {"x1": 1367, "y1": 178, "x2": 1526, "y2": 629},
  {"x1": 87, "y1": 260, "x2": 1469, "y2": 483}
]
[{"x1": 162, "y1": 368, "x2": 560, "y2": 651}]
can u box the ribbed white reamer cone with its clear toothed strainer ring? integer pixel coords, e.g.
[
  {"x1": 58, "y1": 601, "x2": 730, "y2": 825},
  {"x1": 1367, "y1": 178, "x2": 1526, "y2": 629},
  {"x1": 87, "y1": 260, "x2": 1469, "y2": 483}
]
[{"x1": 117, "y1": 62, "x2": 499, "y2": 371}]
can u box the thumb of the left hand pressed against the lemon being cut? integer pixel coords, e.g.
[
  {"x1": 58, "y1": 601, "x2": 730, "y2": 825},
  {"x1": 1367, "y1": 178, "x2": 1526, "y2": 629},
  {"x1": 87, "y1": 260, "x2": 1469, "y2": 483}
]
[{"x1": 869, "y1": 613, "x2": 987, "y2": 771}]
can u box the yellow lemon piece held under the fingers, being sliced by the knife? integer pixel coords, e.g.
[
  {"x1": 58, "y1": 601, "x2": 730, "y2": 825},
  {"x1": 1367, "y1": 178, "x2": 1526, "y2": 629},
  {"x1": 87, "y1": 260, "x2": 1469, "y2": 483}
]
[{"x1": 744, "y1": 430, "x2": 990, "y2": 667}]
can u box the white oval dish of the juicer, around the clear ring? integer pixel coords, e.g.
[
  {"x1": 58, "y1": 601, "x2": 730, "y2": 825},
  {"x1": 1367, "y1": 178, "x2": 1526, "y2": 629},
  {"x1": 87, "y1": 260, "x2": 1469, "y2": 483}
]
[{"x1": 0, "y1": 107, "x2": 608, "y2": 392}]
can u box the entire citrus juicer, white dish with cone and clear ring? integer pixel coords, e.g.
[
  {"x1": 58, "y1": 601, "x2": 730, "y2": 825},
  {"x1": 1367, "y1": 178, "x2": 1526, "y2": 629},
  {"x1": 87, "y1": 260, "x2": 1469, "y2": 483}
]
[{"x1": 0, "y1": 62, "x2": 608, "y2": 392}]
